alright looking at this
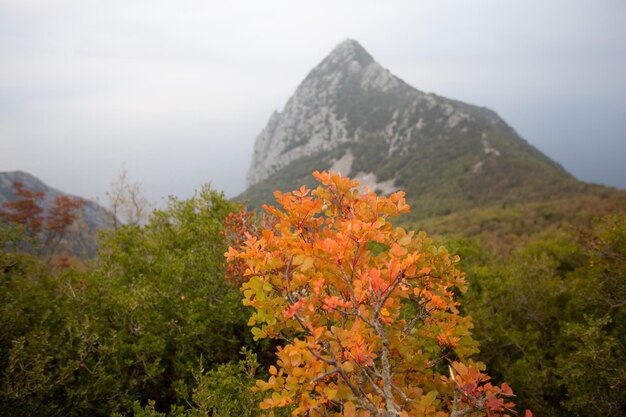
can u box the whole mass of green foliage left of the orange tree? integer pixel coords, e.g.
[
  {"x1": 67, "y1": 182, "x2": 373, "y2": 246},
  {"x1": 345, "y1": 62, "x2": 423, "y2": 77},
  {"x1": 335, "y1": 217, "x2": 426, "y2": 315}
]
[{"x1": 0, "y1": 187, "x2": 252, "y2": 416}]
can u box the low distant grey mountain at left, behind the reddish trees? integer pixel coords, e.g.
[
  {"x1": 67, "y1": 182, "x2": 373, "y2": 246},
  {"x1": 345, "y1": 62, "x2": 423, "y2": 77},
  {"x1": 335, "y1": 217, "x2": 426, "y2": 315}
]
[{"x1": 0, "y1": 171, "x2": 113, "y2": 257}]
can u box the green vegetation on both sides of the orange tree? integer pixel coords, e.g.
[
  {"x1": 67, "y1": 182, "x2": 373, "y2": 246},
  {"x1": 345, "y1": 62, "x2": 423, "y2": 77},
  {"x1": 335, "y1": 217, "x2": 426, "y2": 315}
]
[{"x1": 0, "y1": 174, "x2": 626, "y2": 416}]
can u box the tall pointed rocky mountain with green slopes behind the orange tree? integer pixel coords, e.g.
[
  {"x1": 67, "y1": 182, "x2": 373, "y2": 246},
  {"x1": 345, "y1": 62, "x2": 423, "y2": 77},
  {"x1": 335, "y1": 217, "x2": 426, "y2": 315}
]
[{"x1": 239, "y1": 39, "x2": 613, "y2": 224}]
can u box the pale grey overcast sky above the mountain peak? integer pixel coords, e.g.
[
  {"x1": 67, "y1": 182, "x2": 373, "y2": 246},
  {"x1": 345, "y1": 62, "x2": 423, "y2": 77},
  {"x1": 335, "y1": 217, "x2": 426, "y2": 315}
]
[{"x1": 0, "y1": 0, "x2": 626, "y2": 206}]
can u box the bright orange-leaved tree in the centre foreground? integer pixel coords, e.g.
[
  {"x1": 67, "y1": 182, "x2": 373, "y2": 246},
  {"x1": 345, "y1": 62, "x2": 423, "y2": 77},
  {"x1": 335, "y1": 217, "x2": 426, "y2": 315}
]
[{"x1": 226, "y1": 172, "x2": 530, "y2": 417}]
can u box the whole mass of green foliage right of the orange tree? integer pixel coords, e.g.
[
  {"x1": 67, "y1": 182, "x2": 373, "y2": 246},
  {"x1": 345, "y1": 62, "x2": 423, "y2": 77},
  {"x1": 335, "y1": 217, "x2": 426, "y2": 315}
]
[{"x1": 464, "y1": 215, "x2": 626, "y2": 416}]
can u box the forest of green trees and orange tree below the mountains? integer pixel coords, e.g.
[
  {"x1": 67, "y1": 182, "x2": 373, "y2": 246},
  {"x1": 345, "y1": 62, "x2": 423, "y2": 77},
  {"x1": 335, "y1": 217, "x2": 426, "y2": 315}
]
[{"x1": 0, "y1": 172, "x2": 626, "y2": 417}]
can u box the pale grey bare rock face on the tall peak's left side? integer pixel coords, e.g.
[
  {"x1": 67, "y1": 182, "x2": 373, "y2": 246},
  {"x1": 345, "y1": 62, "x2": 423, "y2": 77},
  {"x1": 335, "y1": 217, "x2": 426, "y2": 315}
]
[{"x1": 247, "y1": 39, "x2": 404, "y2": 186}]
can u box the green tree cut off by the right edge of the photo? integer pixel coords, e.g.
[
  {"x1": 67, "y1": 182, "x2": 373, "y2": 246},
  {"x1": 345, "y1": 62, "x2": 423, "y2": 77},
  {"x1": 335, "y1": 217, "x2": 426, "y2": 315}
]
[{"x1": 556, "y1": 214, "x2": 626, "y2": 417}]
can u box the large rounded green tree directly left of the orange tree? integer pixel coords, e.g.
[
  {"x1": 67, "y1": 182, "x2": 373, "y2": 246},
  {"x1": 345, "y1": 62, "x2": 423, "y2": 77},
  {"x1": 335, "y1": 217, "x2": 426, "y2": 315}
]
[{"x1": 77, "y1": 186, "x2": 251, "y2": 412}]
